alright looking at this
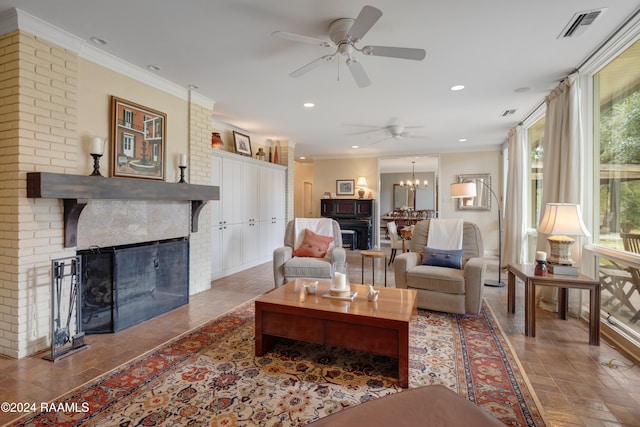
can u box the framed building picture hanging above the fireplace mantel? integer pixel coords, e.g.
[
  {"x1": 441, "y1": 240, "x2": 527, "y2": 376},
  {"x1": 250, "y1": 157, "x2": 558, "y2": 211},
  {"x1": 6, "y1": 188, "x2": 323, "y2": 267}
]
[{"x1": 109, "y1": 96, "x2": 167, "y2": 181}]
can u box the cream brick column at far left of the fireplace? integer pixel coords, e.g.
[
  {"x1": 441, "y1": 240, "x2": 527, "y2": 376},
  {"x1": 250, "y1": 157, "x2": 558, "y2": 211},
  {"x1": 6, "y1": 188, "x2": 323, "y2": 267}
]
[{"x1": 0, "y1": 31, "x2": 77, "y2": 358}]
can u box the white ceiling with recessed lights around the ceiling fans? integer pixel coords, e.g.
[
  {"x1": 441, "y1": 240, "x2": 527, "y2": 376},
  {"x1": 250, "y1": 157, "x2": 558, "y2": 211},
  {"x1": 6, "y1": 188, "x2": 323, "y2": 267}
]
[{"x1": 0, "y1": 0, "x2": 640, "y2": 168}]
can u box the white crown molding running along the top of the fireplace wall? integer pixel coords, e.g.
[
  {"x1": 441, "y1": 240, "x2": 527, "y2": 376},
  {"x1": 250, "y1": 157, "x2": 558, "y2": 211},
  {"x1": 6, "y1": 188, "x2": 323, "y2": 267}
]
[{"x1": 0, "y1": 8, "x2": 215, "y2": 110}]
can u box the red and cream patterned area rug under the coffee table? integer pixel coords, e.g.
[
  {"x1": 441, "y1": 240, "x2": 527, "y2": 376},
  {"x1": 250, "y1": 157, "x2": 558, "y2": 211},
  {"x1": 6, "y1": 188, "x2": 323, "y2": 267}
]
[{"x1": 13, "y1": 302, "x2": 544, "y2": 426}]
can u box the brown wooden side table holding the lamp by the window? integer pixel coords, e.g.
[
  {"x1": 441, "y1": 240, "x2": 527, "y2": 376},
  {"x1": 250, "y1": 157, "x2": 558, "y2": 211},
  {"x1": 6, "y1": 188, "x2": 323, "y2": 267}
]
[{"x1": 507, "y1": 264, "x2": 600, "y2": 345}]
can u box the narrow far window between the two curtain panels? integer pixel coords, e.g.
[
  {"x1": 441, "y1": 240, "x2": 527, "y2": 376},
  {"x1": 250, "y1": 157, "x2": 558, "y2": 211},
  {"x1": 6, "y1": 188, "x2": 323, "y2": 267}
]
[{"x1": 527, "y1": 117, "x2": 545, "y2": 229}]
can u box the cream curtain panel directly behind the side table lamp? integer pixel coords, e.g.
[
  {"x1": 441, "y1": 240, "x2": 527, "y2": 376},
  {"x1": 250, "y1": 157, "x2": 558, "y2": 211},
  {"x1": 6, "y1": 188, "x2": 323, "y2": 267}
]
[{"x1": 537, "y1": 73, "x2": 583, "y2": 311}]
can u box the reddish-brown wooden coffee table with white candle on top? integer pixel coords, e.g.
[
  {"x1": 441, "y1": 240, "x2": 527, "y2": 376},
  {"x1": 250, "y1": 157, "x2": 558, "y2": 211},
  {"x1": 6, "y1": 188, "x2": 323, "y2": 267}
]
[{"x1": 255, "y1": 279, "x2": 417, "y2": 388}]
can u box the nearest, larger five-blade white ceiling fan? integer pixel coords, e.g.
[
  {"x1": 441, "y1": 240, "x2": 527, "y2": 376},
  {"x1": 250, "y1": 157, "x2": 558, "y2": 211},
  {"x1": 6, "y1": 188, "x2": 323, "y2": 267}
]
[{"x1": 271, "y1": 6, "x2": 426, "y2": 87}]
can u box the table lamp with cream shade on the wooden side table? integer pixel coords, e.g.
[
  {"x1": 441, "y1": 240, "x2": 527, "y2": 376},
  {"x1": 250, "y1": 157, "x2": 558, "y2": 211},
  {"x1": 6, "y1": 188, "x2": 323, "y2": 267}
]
[{"x1": 538, "y1": 203, "x2": 591, "y2": 265}]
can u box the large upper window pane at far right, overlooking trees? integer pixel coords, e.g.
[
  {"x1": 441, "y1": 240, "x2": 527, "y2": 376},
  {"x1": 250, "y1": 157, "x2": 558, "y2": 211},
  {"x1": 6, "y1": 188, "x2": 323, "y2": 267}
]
[{"x1": 593, "y1": 41, "x2": 640, "y2": 249}]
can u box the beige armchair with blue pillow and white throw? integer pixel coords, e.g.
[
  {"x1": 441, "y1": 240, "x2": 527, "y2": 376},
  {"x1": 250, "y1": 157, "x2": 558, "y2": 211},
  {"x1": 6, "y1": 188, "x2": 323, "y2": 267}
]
[{"x1": 395, "y1": 219, "x2": 487, "y2": 314}]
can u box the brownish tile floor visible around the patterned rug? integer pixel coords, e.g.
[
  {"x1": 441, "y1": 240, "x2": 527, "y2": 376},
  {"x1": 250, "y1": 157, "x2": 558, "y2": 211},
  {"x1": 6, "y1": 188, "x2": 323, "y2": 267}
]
[{"x1": 0, "y1": 251, "x2": 640, "y2": 426}]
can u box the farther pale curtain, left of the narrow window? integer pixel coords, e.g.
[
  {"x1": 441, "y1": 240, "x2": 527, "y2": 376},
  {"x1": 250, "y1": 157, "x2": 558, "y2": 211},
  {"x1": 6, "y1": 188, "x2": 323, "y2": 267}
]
[{"x1": 502, "y1": 125, "x2": 537, "y2": 265}]
